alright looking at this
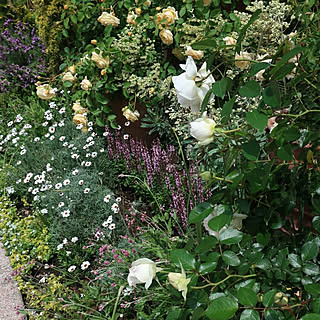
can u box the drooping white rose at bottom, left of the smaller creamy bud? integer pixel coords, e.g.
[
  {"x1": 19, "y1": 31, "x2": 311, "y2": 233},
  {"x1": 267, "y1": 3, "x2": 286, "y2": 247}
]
[{"x1": 128, "y1": 258, "x2": 161, "y2": 290}]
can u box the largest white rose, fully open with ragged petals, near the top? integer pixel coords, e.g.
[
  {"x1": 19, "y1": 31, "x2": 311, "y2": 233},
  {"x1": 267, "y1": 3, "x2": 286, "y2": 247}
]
[{"x1": 172, "y1": 57, "x2": 215, "y2": 112}]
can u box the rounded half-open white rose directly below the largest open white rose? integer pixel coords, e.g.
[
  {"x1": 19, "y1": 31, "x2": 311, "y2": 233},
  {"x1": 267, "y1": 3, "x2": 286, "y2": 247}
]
[{"x1": 190, "y1": 112, "x2": 216, "y2": 146}]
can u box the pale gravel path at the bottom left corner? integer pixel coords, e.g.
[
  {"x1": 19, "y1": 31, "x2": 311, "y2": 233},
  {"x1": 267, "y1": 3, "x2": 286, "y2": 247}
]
[{"x1": 0, "y1": 243, "x2": 24, "y2": 320}]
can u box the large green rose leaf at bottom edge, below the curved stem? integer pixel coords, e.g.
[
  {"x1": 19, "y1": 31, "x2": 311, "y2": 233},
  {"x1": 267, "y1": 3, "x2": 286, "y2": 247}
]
[{"x1": 206, "y1": 297, "x2": 238, "y2": 320}]
